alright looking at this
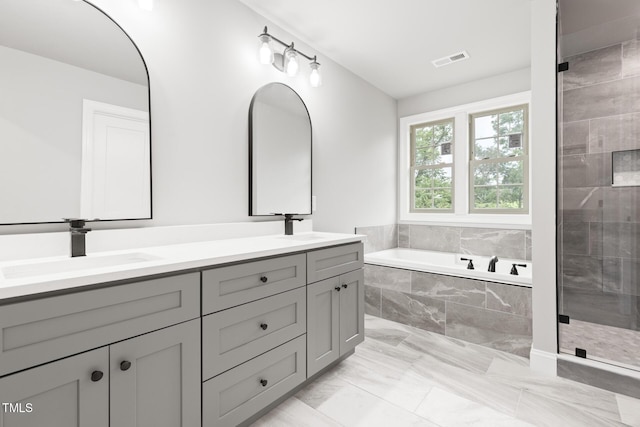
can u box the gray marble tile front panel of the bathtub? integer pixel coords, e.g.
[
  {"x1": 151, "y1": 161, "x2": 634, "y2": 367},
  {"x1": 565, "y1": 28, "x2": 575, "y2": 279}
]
[{"x1": 364, "y1": 264, "x2": 532, "y2": 357}]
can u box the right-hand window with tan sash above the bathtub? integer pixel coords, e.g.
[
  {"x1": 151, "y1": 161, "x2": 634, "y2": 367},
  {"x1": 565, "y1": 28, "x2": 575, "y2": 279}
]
[{"x1": 469, "y1": 105, "x2": 529, "y2": 213}]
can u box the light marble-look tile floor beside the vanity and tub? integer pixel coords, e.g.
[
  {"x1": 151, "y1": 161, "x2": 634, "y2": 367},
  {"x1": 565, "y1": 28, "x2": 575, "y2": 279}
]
[{"x1": 253, "y1": 315, "x2": 640, "y2": 427}]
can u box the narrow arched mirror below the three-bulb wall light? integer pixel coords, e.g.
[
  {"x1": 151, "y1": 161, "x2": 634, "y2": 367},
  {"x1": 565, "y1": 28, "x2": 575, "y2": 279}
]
[{"x1": 249, "y1": 83, "x2": 311, "y2": 215}]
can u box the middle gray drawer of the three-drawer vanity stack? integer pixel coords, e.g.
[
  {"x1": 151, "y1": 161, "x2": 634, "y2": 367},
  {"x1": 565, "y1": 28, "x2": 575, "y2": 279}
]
[{"x1": 202, "y1": 288, "x2": 307, "y2": 380}]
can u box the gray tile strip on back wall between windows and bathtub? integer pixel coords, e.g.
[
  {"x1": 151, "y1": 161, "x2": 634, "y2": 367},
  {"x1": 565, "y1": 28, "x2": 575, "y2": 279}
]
[{"x1": 398, "y1": 224, "x2": 531, "y2": 260}]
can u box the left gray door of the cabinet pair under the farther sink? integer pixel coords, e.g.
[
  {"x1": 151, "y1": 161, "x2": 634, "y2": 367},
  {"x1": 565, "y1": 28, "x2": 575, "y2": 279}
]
[{"x1": 307, "y1": 277, "x2": 341, "y2": 377}]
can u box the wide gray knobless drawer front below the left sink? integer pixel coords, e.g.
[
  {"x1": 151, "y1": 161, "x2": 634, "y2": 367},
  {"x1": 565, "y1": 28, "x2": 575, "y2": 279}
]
[{"x1": 0, "y1": 273, "x2": 200, "y2": 375}]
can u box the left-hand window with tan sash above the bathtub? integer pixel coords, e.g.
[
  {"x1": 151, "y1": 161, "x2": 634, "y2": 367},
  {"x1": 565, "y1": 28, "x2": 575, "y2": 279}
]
[{"x1": 411, "y1": 118, "x2": 454, "y2": 212}]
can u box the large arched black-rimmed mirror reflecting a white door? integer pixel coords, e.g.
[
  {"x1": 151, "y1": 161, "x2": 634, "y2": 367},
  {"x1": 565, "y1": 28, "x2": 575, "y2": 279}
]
[{"x1": 0, "y1": 0, "x2": 151, "y2": 224}]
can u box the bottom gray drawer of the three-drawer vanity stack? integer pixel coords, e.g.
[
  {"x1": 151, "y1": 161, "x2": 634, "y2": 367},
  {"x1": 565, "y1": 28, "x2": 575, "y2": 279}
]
[{"x1": 202, "y1": 335, "x2": 306, "y2": 427}]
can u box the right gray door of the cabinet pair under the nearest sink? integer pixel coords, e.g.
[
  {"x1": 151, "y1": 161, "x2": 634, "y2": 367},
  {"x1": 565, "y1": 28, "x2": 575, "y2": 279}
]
[{"x1": 110, "y1": 319, "x2": 201, "y2": 427}]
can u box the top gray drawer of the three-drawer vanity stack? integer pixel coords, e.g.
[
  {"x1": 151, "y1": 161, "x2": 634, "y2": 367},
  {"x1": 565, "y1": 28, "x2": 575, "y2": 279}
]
[{"x1": 202, "y1": 254, "x2": 306, "y2": 314}]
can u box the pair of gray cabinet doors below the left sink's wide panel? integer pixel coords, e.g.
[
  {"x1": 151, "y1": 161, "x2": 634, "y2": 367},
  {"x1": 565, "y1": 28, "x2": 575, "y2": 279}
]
[{"x1": 0, "y1": 319, "x2": 200, "y2": 427}]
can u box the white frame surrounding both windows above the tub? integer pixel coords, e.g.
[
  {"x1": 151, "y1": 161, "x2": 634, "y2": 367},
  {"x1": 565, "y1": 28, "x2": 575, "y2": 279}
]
[{"x1": 398, "y1": 91, "x2": 534, "y2": 229}]
